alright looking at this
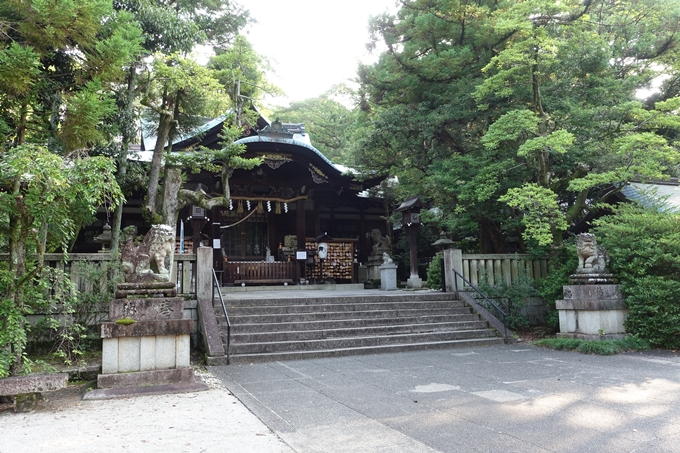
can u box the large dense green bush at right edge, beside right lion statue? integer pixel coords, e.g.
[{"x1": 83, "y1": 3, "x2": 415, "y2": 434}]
[{"x1": 595, "y1": 202, "x2": 680, "y2": 348}]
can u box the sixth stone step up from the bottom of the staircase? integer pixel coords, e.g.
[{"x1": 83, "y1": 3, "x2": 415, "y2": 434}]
[{"x1": 227, "y1": 300, "x2": 465, "y2": 318}]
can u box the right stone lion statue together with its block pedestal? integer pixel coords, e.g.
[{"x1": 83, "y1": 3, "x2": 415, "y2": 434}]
[{"x1": 555, "y1": 233, "x2": 628, "y2": 340}]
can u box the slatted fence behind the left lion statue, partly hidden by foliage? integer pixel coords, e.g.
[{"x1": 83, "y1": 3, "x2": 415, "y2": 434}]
[{"x1": 0, "y1": 253, "x2": 196, "y2": 295}]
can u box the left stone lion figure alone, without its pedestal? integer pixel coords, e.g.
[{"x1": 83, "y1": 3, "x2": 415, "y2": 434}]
[{"x1": 121, "y1": 225, "x2": 175, "y2": 280}]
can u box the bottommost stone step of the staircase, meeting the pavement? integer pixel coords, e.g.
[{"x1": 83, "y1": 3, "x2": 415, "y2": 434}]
[{"x1": 231, "y1": 337, "x2": 503, "y2": 364}]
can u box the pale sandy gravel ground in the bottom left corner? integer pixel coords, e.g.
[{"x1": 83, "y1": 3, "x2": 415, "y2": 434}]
[{"x1": 0, "y1": 369, "x2": 293, "y2": 453}]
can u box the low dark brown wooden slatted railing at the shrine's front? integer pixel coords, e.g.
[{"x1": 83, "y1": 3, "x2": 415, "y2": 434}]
[{"x1": 223, "y1": 261, "x2": 297, "y2": 285}]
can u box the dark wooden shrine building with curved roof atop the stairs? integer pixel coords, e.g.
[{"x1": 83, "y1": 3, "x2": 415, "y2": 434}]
[{"x1": 85, "y1": 117, "x2": 388, "y2": 285}]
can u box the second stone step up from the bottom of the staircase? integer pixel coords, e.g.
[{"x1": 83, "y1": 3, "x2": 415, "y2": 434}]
[{"x1": 231, "y1": 329, "x2": 496, "y2": 354}]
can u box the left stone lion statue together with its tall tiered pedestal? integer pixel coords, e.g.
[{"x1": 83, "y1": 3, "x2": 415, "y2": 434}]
[{"x1": 90, "y1": 225, "x2": 207, "y2": 398}]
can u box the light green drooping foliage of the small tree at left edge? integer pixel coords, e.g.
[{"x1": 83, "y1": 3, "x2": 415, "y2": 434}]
[{"x1": 0, "y1": 145, "x2": 122, "y2": 375}]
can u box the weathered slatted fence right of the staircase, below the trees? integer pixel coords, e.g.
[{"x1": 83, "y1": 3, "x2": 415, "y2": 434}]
[{"x1": 456, "y1": 254, "x2": 548, "y2": 286}]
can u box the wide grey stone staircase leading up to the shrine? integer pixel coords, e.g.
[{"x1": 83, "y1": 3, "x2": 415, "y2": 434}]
[{"x1": 215, "y1": 291, "x2": 503, "y2": 363}]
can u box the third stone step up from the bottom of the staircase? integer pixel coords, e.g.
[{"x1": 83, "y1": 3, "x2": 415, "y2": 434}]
[{"x1": 231, "y1": 321, "x2": 488, "y2": 344}]
